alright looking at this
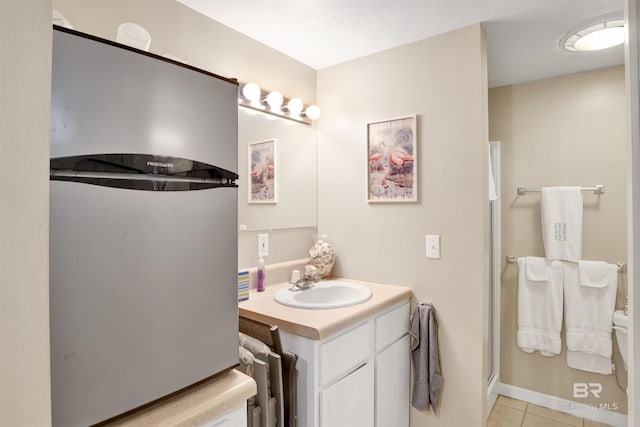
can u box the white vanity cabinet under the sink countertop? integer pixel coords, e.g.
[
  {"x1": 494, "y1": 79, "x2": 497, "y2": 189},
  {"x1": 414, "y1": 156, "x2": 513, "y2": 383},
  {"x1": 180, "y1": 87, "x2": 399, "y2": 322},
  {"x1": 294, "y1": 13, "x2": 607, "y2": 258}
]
[{"x1": 281, "y1": 299, "x2": 409, "y2": 427}]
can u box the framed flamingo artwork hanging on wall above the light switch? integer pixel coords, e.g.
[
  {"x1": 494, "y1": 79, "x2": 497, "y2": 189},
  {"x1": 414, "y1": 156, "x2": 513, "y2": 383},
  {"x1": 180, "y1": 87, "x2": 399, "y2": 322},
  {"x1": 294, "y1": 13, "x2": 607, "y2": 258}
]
[{"x1": 367, "y1": 116, "x2": 418, "y2": 202}]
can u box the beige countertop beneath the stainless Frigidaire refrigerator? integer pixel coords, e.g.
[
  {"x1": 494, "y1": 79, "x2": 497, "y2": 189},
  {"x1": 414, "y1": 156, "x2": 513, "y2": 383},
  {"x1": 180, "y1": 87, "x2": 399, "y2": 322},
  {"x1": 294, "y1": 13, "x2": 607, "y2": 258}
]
[{"x1": 105, "y1": 369, "x2": 256, "y2": 427}]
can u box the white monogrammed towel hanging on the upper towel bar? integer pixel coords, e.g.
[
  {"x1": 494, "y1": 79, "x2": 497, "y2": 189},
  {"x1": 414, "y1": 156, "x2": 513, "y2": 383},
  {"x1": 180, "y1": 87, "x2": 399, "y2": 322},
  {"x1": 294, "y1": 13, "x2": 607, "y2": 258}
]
[{"x1": 541, "y1": 187, "x2": 582, "y2": 262}]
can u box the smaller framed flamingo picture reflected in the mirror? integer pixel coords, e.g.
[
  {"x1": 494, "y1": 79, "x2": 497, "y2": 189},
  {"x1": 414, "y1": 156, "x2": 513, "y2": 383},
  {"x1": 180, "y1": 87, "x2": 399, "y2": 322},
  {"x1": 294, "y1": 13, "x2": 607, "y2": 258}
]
[{"x1": 248, "y1": 139, "x2": 278, "y2": 203}]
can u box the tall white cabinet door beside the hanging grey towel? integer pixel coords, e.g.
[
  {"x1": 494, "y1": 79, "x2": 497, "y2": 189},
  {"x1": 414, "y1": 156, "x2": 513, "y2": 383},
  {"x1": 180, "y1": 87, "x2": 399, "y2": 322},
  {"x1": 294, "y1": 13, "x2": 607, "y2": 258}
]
[{"x1": 375, "y1": 335, "x2": 409, "y2": 427}]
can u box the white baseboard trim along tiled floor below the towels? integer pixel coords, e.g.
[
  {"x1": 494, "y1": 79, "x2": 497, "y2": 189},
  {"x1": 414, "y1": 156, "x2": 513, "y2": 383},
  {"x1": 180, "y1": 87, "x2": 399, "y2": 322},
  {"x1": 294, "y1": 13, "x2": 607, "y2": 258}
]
[{"x1": 500, "y1": 383, "x2": 627, "y2": 427}]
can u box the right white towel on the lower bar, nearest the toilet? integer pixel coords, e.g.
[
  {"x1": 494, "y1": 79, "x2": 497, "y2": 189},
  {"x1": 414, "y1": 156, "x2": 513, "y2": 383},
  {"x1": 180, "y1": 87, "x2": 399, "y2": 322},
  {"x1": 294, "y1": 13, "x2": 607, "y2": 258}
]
[{"x1": 564, "y1": 262, "x2": 618, "y2": 375}]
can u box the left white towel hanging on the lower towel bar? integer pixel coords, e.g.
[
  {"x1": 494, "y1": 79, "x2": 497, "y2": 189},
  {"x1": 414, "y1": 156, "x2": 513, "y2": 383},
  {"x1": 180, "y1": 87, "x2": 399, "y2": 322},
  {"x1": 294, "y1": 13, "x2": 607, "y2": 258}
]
[{"x1": 517, "y1": 257, "x2": 563, "y2": 356}]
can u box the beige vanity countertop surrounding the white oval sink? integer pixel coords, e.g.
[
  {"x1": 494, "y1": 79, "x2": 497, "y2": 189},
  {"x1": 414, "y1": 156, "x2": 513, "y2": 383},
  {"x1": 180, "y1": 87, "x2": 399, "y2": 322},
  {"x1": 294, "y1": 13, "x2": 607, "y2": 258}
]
[{"x1": 239, "y1": 277, "x2": 412, "y2": 340}]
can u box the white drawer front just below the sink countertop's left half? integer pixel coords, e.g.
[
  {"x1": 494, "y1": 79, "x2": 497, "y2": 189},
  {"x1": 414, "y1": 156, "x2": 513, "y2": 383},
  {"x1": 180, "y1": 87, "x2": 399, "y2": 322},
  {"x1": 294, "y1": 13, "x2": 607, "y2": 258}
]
[{"x1": 320, "y1": 322, "x2": 371, "y2": 385}]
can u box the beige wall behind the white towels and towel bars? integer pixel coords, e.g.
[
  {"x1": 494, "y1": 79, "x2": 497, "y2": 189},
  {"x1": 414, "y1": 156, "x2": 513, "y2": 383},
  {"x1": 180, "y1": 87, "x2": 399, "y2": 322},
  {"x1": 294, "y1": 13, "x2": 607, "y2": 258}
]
[{"x1": 489, "y1": 67, "x2": 628, "y2": 413}]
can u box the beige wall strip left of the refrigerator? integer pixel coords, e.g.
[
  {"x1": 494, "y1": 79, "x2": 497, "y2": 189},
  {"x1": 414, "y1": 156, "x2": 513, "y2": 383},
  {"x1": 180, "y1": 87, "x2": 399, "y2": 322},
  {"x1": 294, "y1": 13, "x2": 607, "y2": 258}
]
[{"x1": 0, "y1": 0, "x2": 51, "y2": 426}]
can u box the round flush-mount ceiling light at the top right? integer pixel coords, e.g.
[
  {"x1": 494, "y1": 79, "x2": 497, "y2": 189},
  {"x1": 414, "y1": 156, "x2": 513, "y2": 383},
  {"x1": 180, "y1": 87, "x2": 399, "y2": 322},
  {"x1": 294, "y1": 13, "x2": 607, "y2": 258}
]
[{"x1": 560, "y1": 18, "x2": 626, "y2": 52}]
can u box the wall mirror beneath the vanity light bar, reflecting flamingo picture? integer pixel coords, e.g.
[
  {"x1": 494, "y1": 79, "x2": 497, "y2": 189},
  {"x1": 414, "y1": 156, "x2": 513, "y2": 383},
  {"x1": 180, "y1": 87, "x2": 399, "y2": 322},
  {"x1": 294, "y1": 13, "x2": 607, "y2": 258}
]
[{"x1": 238, "y1": 108, "x2": 317, "y2": 231}]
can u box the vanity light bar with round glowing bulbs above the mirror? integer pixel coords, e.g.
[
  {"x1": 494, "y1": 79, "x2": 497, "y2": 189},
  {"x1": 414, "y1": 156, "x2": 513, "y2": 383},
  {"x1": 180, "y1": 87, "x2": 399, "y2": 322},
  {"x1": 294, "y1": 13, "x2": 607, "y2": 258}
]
[{"x1": 238, "y1": 82, "x2": 320, "y2": 125}]
